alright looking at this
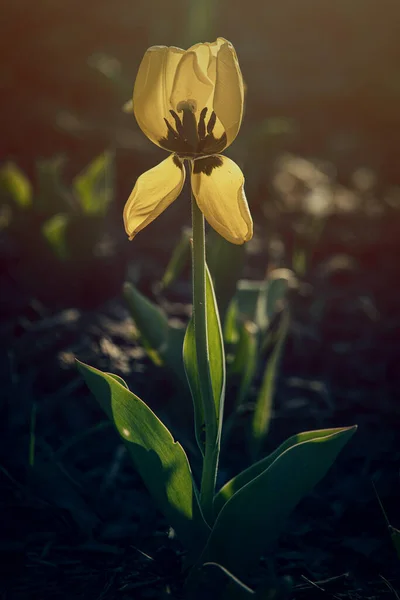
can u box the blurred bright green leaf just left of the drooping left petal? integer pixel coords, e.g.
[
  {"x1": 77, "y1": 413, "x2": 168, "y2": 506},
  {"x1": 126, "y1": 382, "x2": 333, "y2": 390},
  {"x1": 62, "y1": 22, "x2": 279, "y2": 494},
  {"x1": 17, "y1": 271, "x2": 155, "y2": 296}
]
[{"x1": 72, "y1": 152, "x2": 114, "y2": 216}]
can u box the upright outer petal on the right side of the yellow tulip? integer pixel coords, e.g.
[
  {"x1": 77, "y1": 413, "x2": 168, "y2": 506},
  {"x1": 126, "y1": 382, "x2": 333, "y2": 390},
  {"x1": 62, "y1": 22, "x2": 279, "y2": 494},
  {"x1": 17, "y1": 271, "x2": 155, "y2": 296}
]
[{"x1": 213, "y1": 38, "x2": 244, "y2": 146}]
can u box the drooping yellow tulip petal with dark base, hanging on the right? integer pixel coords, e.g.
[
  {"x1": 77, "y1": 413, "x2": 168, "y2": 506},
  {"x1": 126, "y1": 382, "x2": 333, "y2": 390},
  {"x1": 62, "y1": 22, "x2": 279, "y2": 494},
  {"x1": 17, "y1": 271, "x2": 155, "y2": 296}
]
[{"x1": 191, "y1": 156, "x2": 253, "y2": 244}]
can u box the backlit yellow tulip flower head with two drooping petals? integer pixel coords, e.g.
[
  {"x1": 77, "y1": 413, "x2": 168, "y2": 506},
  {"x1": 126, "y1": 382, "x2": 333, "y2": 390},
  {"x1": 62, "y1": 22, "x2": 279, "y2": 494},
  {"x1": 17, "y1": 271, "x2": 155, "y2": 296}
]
[{"x1": 124, "y1": 38, "x2": 253, "y2": 244}]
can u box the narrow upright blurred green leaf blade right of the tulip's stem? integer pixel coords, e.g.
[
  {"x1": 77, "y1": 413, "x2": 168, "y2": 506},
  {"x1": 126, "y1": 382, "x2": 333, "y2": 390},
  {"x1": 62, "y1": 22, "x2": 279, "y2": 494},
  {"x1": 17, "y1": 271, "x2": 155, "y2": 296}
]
[{"x1": 250, "y1": 311, "x2": 289, "y2": 457}]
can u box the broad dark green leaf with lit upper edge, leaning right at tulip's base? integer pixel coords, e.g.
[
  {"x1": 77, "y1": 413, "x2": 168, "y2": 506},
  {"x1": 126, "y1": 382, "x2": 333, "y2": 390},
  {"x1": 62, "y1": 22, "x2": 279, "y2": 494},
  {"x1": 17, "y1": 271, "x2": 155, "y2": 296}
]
[{"x1": 206, "y1": 426, "x2": 356, "y2": 577}]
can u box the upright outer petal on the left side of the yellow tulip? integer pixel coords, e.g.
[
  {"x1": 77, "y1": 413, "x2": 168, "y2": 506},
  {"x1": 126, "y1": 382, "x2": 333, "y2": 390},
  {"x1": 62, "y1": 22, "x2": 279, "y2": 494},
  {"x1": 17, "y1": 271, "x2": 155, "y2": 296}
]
[{"x1": 133, "y1": 46, "x2": 185, "y2": 146}]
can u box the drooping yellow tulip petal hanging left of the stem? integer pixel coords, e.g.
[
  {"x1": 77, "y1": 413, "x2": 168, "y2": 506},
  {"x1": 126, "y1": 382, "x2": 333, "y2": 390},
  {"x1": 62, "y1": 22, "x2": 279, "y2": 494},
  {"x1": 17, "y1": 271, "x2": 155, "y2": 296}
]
[{"x1": 123, "y1": 155, "x2": 185, "y2": 240}]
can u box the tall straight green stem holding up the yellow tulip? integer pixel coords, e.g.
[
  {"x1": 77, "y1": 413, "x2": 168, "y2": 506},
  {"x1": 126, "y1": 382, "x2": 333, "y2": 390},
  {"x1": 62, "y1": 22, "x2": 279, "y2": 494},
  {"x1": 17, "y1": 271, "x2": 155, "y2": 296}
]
[{"x1": 192, "y1": 185, "x2": 219, "y2": 524}]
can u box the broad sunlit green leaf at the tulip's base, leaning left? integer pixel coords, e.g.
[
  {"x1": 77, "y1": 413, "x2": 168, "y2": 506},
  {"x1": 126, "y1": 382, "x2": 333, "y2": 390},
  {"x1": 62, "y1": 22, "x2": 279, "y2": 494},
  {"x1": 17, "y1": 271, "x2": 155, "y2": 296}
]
[{"x1": 77, "y1": 361, "x2": 208, "y2": 549}]
